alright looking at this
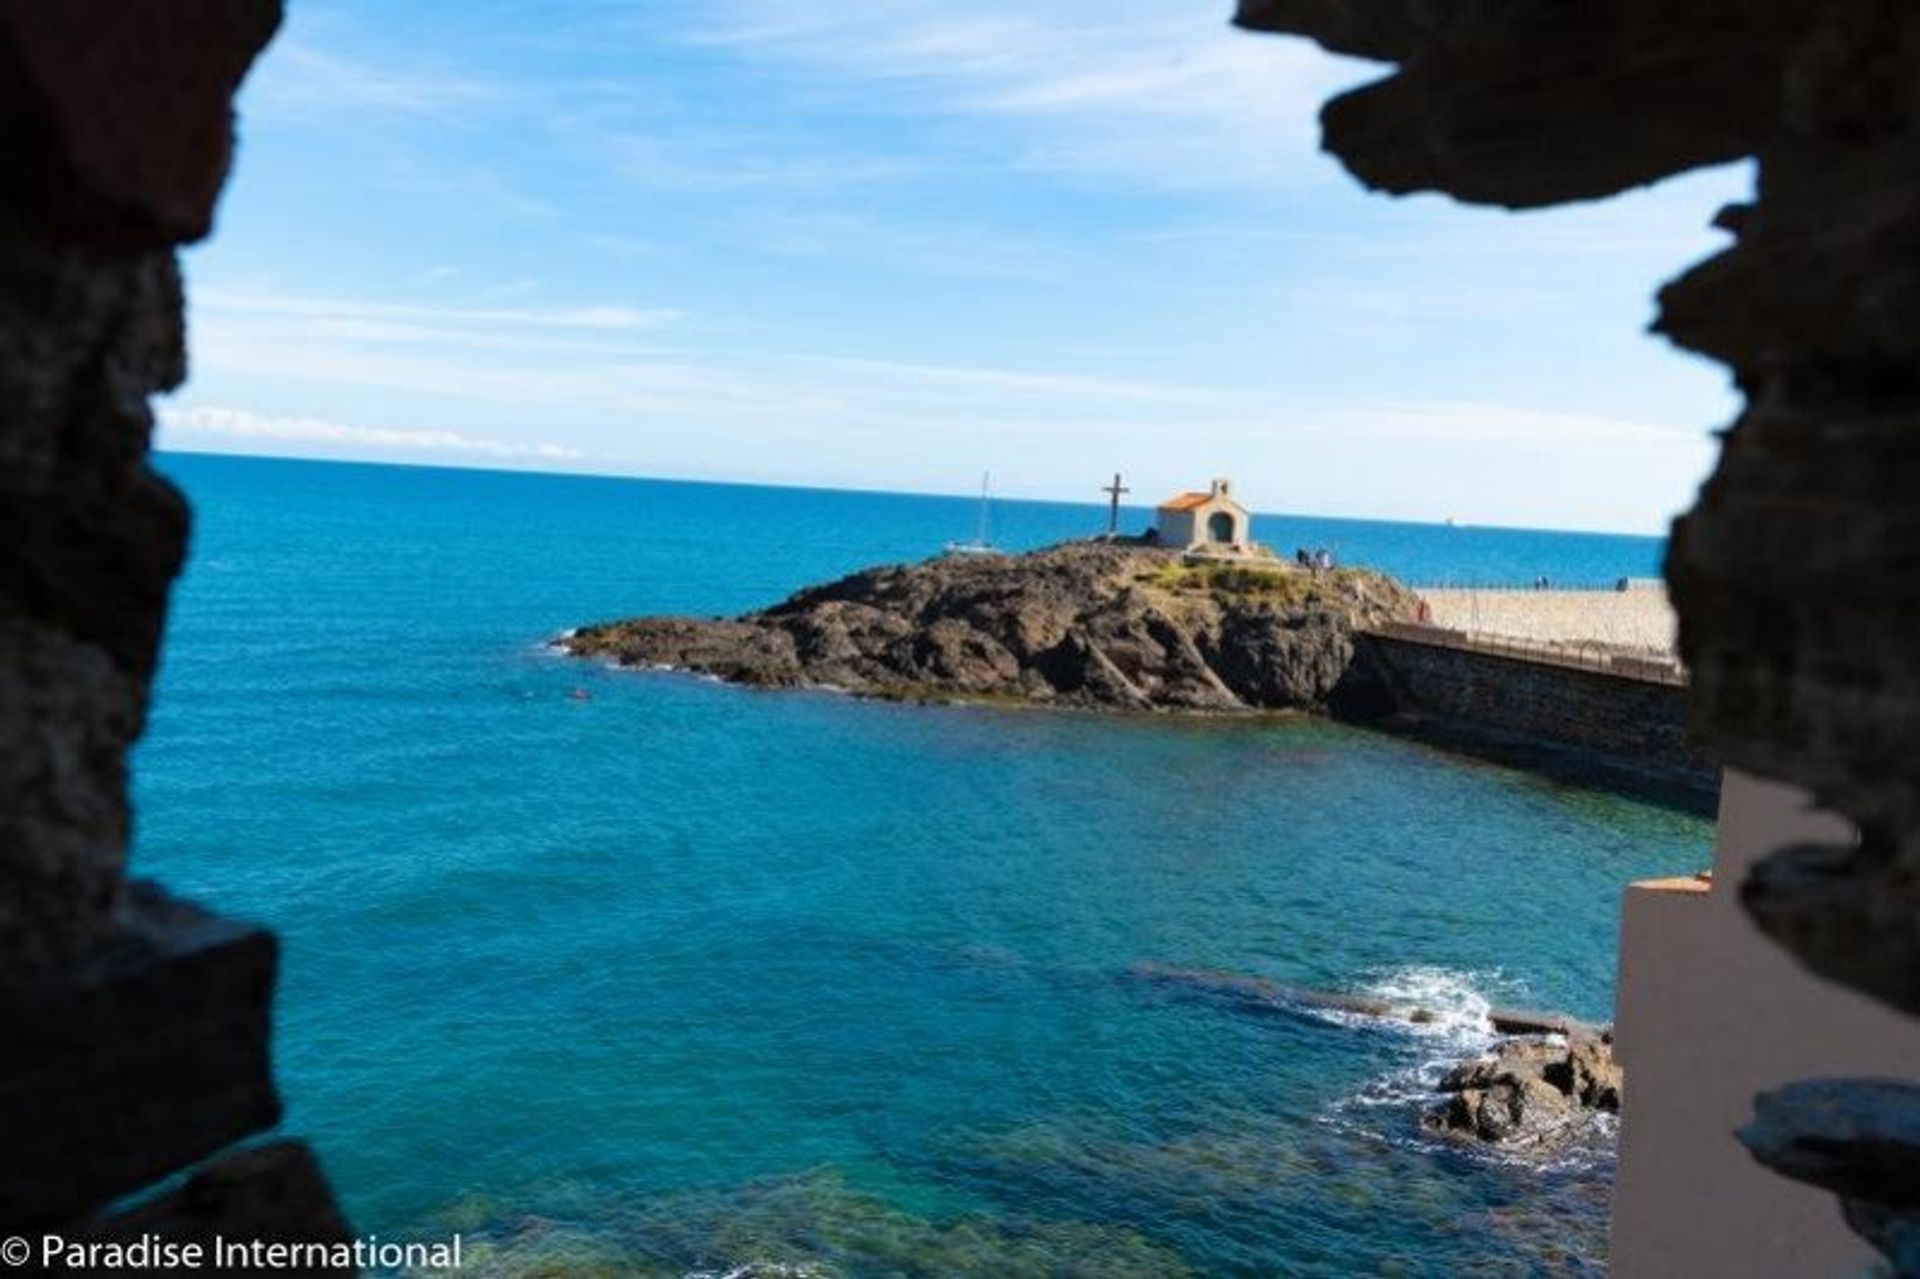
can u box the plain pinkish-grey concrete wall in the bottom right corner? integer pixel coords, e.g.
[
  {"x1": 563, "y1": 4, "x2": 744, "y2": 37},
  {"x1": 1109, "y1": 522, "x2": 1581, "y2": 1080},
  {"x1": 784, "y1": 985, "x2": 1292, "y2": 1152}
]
[{"x1": 1613, "y1": 772, "x2": 1920, "y2": 1279}]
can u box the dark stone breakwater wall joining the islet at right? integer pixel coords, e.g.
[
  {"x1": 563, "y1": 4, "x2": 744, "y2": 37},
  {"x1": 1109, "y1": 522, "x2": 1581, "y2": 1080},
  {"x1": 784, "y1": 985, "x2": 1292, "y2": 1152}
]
[{"x1": 1334, "y1": 626, "x2": 1718, "y2": 814}]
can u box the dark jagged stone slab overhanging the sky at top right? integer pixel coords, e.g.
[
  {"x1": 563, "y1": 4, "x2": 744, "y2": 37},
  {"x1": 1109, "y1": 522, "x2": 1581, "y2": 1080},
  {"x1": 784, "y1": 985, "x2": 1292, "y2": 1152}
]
[{"x1": 1236, "y1": 0, "x2": 1818, "y2": 207}]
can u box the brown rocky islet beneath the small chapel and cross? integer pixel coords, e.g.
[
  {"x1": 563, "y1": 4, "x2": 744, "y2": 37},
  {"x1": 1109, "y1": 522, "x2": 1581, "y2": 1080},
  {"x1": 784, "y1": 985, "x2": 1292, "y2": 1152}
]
[{"x1": 564, "y1": 542, "x2": 1417, "y2": 712}]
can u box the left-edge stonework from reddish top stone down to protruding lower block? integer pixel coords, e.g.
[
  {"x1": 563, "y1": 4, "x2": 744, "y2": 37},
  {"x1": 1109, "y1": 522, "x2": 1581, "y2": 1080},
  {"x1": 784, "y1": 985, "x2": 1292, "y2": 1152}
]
[{"x1": 0, "y1": 0, "x2": 280, "y2": 966}]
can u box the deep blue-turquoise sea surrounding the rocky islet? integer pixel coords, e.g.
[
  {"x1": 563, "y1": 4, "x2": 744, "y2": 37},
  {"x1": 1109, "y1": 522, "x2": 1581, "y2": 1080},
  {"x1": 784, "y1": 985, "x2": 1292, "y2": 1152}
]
[{"x1": 134, "y1": 455, "x2": 1711, "y2": 1279}]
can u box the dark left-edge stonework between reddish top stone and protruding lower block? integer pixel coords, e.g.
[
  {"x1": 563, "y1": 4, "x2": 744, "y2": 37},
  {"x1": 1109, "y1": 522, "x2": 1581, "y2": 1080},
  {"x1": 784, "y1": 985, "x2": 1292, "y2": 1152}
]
[{"x1": 0, "y1": 209, "x2": 186, "y2": 966}]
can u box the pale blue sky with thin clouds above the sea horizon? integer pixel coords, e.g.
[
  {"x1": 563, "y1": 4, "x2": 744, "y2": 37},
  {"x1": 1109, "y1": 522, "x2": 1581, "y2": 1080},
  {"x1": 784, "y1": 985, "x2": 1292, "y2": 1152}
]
[{"x1": 159, "y1": 0, "x2": 1751, "y2": 532}]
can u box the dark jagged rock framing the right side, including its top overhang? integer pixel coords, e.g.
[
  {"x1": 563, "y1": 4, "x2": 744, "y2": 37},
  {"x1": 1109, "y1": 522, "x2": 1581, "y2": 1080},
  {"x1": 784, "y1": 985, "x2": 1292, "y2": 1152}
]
[{"x1": 1238, "y1": 0, "x2": 1920, "y2": 1264}]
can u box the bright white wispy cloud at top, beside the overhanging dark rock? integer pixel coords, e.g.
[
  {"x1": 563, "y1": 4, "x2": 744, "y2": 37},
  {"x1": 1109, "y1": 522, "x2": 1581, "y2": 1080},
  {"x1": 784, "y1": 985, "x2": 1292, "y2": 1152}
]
[{"x1": 675, "y1": 0, "x2": 1357, "y2": 188}]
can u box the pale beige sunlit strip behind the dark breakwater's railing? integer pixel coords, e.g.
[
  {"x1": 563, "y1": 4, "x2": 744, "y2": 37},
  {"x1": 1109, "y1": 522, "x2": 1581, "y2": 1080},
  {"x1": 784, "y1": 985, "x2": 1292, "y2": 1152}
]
[{"x1": 1419, "y1": 588, "x2": 1674, "y2": 653}]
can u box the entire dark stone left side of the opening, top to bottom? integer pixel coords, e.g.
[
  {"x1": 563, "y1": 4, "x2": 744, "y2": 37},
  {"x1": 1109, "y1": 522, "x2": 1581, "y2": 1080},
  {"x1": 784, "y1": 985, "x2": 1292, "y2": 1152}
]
[{"x1": 0, "y1": 0, "x2": 349, "y2": 1239}]
